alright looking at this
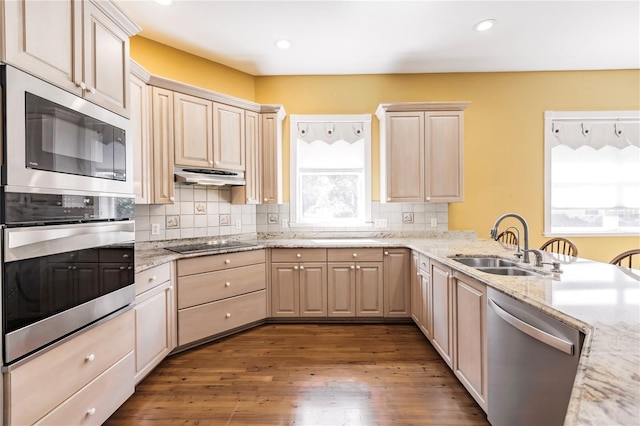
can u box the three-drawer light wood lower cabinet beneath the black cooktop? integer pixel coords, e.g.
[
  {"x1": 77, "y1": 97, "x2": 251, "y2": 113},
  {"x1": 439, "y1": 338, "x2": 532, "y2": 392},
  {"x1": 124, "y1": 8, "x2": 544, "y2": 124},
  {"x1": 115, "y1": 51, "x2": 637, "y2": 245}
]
[{"x1": 176, "y1": 250, "x2": 267, "y2": 346}]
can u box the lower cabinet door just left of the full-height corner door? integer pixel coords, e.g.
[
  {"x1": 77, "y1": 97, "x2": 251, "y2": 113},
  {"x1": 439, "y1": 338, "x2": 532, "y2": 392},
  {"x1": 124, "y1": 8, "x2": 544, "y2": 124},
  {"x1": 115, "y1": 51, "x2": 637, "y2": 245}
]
[{"x1": 356, "y1": 262, "x2": 384, "y2": 317}]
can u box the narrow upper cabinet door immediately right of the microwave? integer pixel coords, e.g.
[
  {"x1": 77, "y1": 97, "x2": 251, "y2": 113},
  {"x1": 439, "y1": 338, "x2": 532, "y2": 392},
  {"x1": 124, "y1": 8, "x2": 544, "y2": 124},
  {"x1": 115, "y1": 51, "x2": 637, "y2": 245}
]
[{"x1": 128, "y1": 75, "x2": 153, "y2": 204}]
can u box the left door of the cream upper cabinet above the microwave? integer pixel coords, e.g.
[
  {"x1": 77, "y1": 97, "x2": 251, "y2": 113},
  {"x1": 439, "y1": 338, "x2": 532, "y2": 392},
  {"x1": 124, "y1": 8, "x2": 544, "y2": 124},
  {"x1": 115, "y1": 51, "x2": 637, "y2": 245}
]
[{"x1": 3, "y1": 0, "x2": 82, "y2": 95}]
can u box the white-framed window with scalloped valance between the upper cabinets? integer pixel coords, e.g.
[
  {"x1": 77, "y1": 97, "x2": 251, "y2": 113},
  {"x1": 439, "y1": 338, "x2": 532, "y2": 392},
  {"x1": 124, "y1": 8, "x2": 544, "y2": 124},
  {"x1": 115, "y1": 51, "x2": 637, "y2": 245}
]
[{"x1": 290, "y1": 114, "x2": 371, "y2": 226}]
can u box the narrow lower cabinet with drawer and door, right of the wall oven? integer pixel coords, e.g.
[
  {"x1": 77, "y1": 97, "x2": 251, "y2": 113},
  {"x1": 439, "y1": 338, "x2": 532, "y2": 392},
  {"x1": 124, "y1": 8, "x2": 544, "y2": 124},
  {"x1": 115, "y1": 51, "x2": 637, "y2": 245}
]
[{"x1": 134, "y1": 263, "x2": 177, "y2": 384}]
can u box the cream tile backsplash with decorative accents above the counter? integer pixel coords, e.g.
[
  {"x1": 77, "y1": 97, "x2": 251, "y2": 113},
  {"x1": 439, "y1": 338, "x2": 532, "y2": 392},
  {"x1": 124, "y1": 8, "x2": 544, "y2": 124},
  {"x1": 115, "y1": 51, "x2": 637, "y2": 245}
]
[{"x1": 136, "y1": 185, "x2": 449, "y2": 242}]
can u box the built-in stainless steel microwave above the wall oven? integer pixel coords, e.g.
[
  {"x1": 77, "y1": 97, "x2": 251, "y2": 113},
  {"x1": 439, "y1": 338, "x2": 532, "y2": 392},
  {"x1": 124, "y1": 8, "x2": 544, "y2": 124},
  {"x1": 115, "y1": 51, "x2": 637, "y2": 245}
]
[{"x1": 0, "y1": 65, "x2": 133, "y2": 196}]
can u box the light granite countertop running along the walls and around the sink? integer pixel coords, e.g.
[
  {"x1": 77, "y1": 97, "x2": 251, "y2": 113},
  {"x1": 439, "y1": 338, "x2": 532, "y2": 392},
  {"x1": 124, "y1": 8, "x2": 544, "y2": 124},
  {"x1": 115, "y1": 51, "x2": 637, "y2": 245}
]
[{"x1": 136, "y1": 233, "x2": 640, "y2": 425}]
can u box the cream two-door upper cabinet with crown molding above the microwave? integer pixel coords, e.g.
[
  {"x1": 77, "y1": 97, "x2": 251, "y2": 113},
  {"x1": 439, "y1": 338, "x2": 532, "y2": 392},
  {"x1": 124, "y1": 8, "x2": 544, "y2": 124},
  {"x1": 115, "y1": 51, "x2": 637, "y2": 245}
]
[{"x1": 2, "y1": 0, "x2": 140, "y2": 117}]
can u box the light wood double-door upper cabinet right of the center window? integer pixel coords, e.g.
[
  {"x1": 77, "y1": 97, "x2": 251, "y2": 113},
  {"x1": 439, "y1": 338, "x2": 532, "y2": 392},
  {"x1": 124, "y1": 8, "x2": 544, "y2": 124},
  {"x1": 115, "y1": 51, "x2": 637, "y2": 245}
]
[{"x1": 376, "y1": 102, "x2": 469, "y2": 203}]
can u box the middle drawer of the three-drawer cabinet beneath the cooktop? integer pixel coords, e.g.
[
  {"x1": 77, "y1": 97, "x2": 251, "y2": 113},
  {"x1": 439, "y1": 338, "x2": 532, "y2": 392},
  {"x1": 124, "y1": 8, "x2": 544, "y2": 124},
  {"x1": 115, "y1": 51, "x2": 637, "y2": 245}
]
[{"x1": 178, "y1": 263, "x2": 266, "y2": 309}]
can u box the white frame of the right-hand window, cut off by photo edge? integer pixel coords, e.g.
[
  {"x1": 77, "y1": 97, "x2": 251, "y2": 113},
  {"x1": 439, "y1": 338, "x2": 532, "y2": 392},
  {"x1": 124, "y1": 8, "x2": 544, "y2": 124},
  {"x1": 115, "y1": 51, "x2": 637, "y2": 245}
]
[{"x1": 543, "y1": 111, "x2": 640, "y2": 237}]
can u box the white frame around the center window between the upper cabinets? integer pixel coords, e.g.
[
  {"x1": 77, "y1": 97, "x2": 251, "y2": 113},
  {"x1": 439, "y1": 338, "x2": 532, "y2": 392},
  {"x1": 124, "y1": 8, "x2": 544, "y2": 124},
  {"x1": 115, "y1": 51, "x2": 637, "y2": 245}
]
[{"x1": 289, "y1": 114, "x2": 372, "y2": 228}]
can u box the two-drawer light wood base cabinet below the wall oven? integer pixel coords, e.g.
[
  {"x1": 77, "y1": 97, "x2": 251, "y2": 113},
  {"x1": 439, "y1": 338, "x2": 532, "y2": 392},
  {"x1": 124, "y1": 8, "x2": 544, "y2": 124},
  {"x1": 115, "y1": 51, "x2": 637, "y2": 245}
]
[{"x1": 3, "y1": 310, "x2": 135, "y2": 425}]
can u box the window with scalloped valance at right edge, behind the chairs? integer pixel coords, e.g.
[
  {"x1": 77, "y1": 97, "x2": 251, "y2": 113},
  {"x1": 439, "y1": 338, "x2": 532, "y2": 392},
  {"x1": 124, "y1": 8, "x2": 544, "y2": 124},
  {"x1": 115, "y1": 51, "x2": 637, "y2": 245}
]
[{"x1": 545, "y1": 111, "x2": 640, "y2": 235}]
